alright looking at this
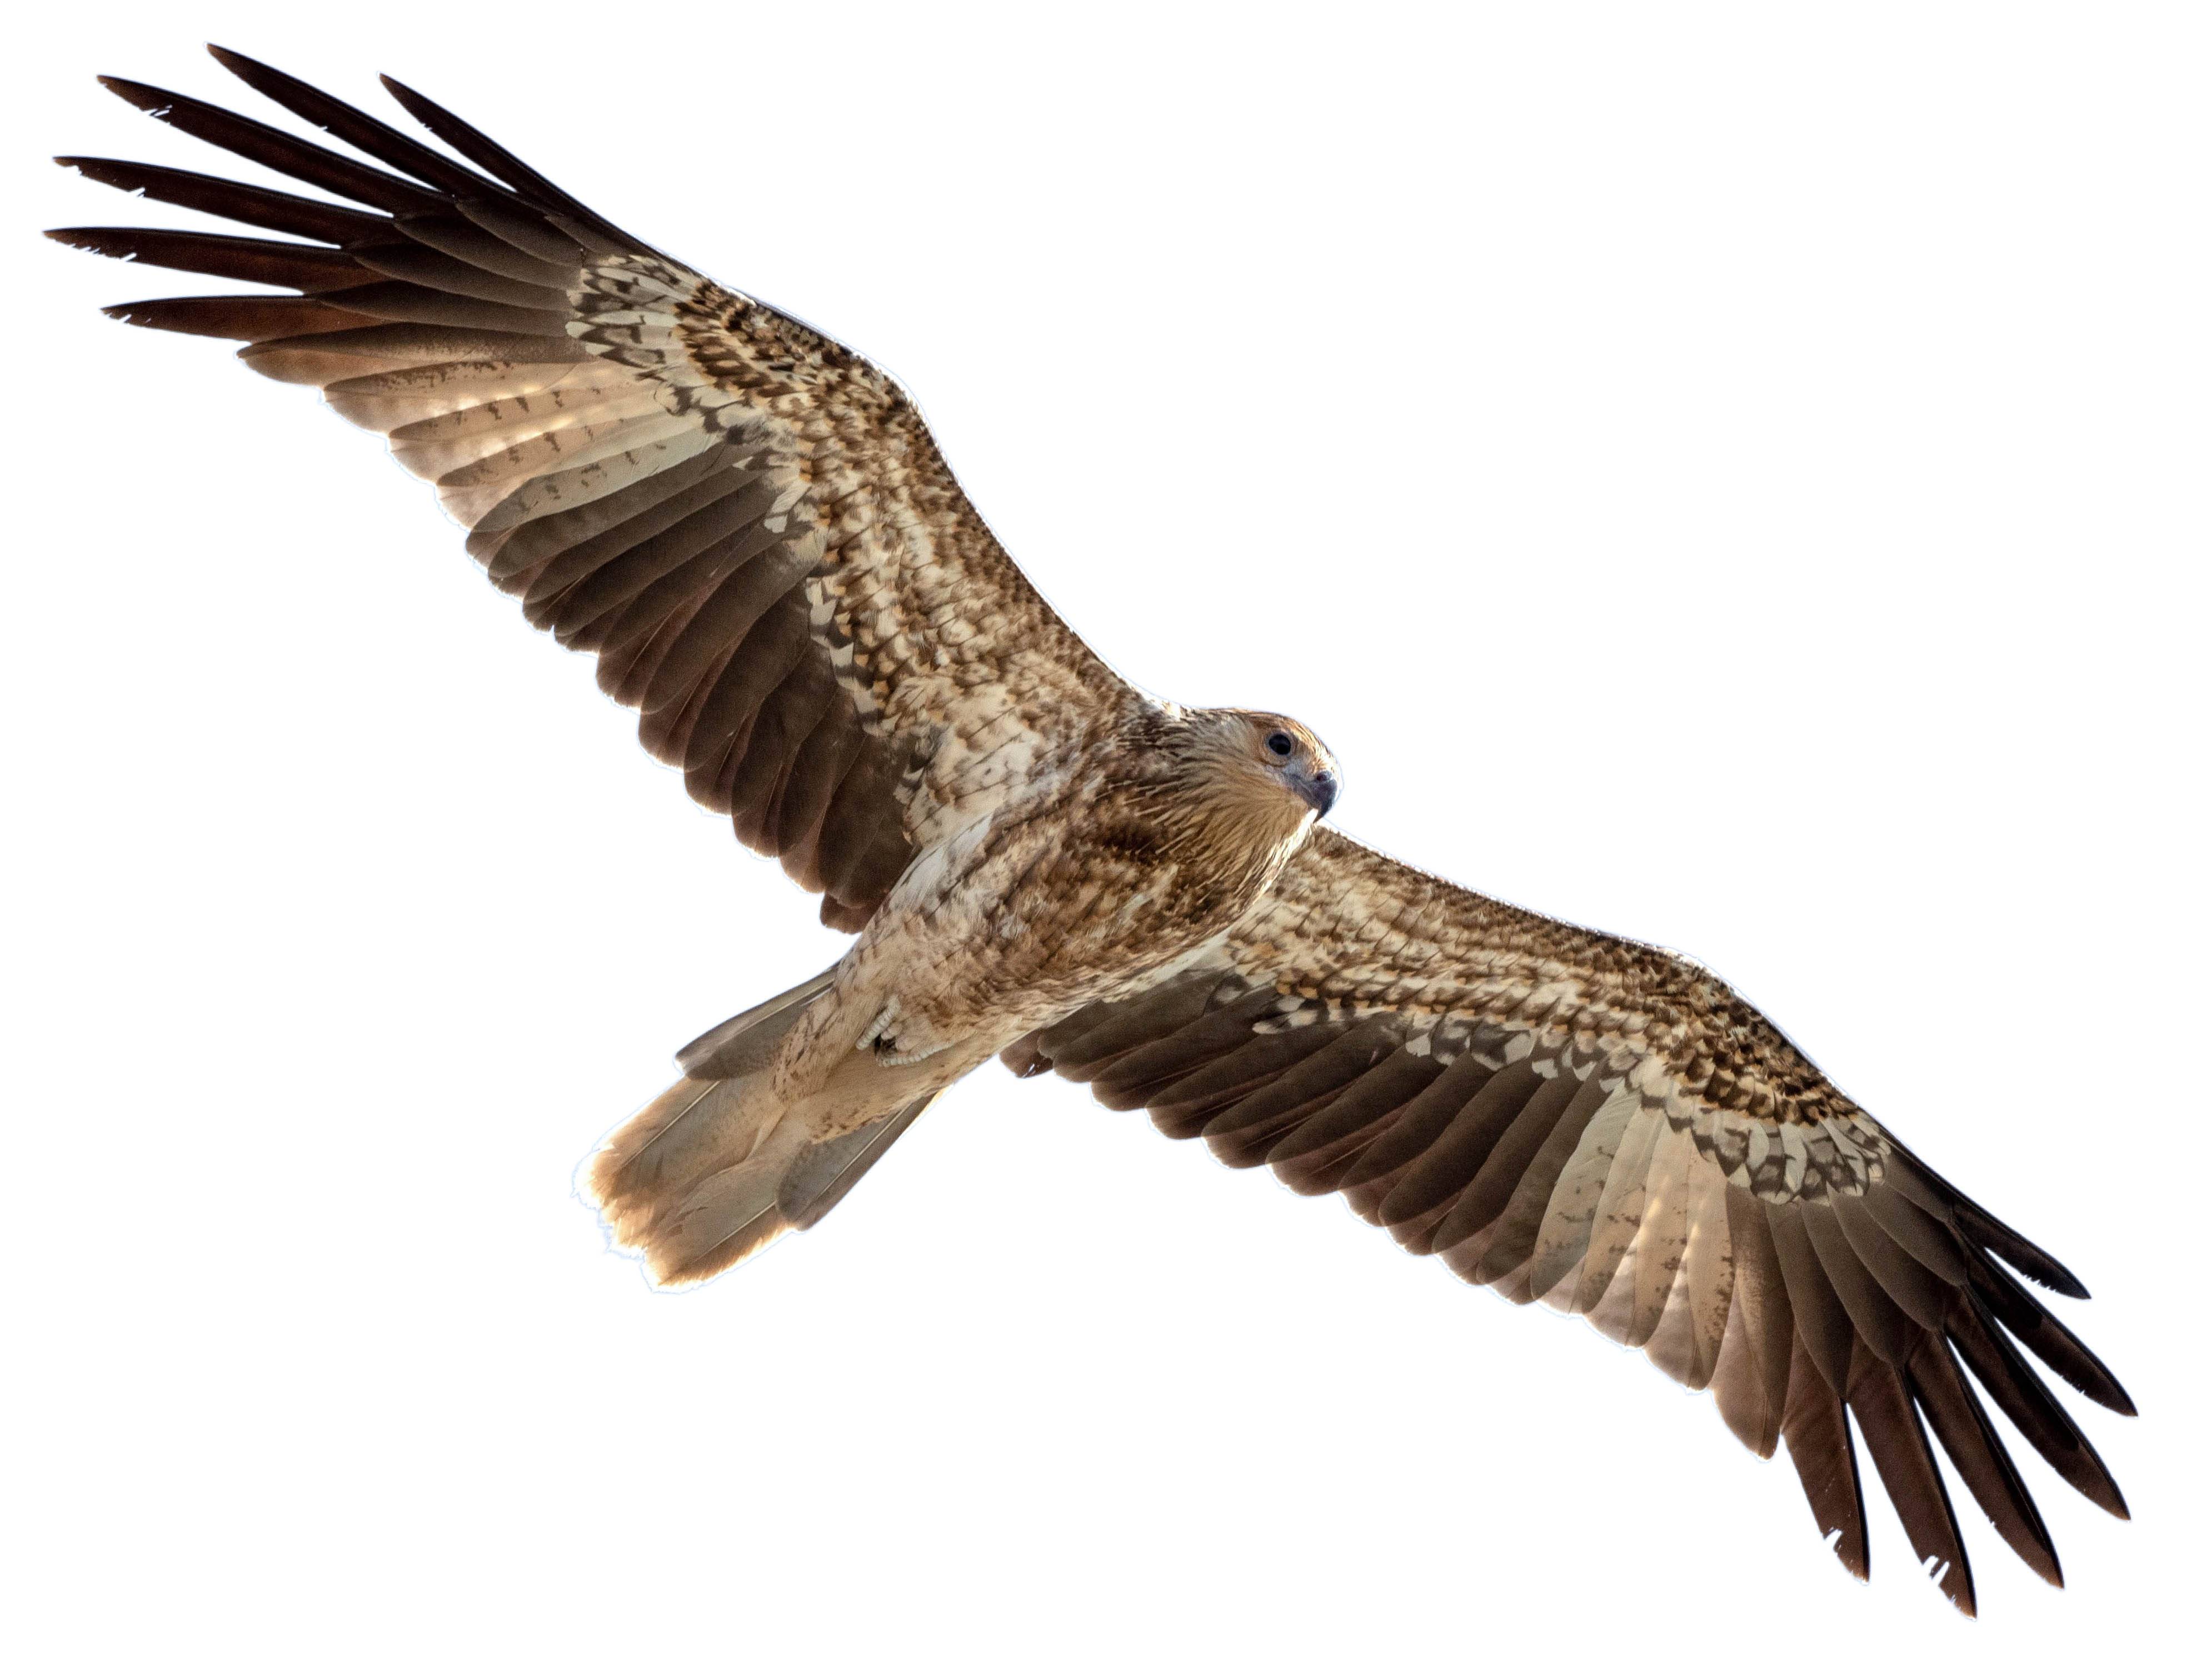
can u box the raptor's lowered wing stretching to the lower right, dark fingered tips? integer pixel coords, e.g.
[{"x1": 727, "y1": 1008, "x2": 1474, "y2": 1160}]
[{"x1": 1004, "y1": 829, "x2": 2135, "y2": 1612}]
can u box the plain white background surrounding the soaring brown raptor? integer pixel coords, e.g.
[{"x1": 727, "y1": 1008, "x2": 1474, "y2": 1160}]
[{"x1": 0, "y1": 0, "x2": 2212, "y2": 1655}]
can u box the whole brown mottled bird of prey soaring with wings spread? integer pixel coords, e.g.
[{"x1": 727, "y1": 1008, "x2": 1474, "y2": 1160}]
[{"x1": 51, "y1": 49, "x2": 2133, "y2": 1612}]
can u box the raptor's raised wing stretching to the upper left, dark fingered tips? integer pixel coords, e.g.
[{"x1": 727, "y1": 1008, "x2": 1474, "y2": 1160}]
[{"x1": 49, "y1": 49, "x2": 1132, "y2": 929}]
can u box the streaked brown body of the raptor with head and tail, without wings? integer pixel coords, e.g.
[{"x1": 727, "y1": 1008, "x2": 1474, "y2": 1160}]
[{"x1": 591, "y1": 703, "x2": 1334, "y2": 1283}]
